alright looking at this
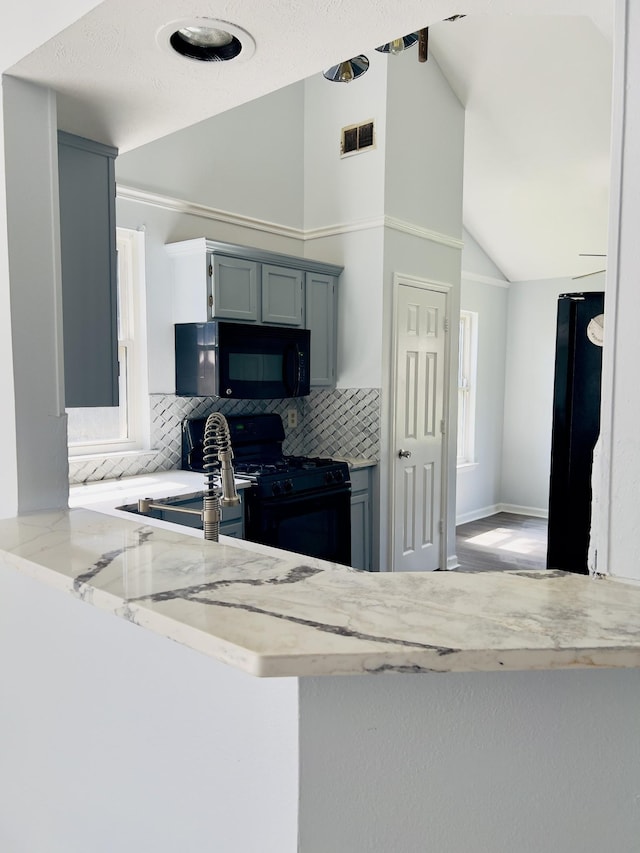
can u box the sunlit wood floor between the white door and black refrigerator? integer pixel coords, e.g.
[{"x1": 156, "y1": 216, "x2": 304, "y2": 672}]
[{"x1": 456, "y1": 512, "x2": 547, "y2": 572}]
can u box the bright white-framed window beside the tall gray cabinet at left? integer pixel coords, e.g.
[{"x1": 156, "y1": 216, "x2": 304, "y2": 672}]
[{"x1": 66, "y1": 228, "x2": 148, "y2": 456}]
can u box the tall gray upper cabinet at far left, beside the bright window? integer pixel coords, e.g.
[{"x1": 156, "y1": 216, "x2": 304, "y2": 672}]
[{"x1": 58, "y1": 131, "x2": 118, "y2": 408}]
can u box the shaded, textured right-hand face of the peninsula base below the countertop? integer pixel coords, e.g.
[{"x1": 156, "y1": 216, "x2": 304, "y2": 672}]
[{"x1": 299, "y1": 670, "x2": 640, "y2": 853}]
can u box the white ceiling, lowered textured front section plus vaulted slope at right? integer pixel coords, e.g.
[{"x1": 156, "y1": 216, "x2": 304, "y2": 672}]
[{"x1": 0, "y1": 0, "x2": 613, "y2": 280}]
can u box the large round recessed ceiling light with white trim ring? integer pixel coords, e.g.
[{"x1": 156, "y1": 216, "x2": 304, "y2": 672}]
[{"x1": 157, "y1": 18, "x2": 256, "y2": 62}]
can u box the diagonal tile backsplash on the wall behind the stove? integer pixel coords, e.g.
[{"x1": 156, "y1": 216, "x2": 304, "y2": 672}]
[{"x1": 69, "y1": 388, "x2": 380, "y2": 483}]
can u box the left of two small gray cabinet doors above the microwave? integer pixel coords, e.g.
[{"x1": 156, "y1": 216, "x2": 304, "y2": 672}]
[{"x1": 210, "y1": 255, "x2": 258, "y2": 323}]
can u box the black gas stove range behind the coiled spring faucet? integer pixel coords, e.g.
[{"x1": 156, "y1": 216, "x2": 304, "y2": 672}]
[{"x1": 182, "y1": 413, "x2": 351, "y2": 565}]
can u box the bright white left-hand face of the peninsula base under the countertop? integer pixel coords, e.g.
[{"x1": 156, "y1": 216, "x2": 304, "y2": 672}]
[{"x1": 0, "y1": 566, "x2": 298, "y2": 853}]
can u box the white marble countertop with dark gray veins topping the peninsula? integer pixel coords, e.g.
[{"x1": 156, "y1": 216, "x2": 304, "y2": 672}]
[{"x1": 0, "y1": 472, "x2": 640, "y2": 676}]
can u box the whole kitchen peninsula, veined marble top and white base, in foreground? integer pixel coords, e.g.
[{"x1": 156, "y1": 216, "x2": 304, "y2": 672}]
[{"x1": 0, "y1": 502, "x2": 640, "y2": 853}]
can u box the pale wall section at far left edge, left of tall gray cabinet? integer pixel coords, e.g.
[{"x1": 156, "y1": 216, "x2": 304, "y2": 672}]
[{"x1": 2, "y1": 77, "x2": 69, "y2": 512}]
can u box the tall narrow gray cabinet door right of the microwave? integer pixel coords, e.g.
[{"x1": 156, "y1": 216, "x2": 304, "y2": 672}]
[{"x1": 305, "y1": 272, "x2": 336, "y2": 385}]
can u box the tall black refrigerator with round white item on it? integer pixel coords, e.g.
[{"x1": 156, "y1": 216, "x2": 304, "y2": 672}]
[{"x1": 547, "y1": 293, "x2": 604, "y2": 574}]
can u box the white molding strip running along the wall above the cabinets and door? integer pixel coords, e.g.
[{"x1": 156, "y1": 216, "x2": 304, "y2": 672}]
[{"x1": 116, "y1": 184, "x2": 463, "y2": 250}]
